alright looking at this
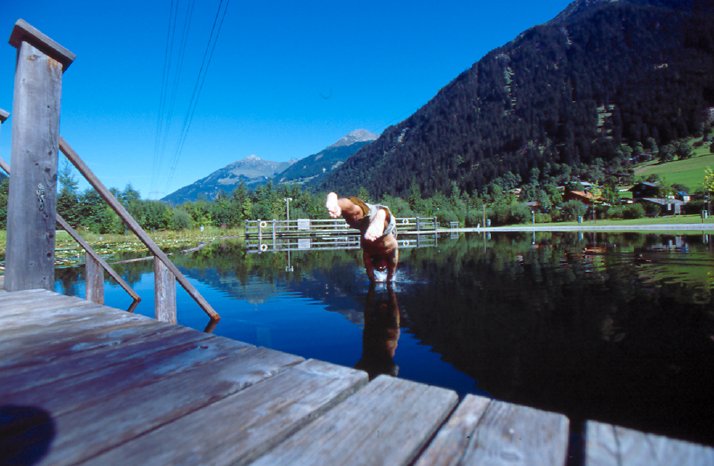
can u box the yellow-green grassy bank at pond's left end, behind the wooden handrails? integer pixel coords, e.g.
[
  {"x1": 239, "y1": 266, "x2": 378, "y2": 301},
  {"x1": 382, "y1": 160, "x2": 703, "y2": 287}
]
[{"x1": 0, "y1": 227, "x2": 243, "y2": 266}]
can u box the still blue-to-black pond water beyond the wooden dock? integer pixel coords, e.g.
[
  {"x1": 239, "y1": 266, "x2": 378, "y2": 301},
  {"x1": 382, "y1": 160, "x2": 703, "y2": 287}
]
[{"x1": 51, "y1": 233, "x2": 714, "y2": 445}]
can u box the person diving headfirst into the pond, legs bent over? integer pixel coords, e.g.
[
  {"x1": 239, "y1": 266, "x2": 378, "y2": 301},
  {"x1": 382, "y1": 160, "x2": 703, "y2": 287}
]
[{"x1": 325, "y1": 193, "x2": 399, "y2": 282}]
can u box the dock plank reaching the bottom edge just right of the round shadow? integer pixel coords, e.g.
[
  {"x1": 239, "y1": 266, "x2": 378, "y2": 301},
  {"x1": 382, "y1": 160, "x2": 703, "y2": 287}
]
[{"x1": 15, "y1": 348, "x2": 301, "y2": 464}]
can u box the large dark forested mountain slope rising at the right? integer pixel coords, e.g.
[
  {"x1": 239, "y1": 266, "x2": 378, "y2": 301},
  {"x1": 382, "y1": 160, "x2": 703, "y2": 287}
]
[{"x1": 319, "y1": 0, "x2": 714, "y2": 197}]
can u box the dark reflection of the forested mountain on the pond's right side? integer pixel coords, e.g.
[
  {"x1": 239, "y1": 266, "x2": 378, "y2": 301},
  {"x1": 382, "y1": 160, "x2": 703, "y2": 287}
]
[{"x1": 400, "y1": 234, "x2": 714, "y2": 442}]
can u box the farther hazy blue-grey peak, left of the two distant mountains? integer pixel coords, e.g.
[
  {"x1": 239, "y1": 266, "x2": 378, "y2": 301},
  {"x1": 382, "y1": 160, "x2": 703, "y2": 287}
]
[{"x1": 161, "y1": 155, "x2": 292, "y2": 204}]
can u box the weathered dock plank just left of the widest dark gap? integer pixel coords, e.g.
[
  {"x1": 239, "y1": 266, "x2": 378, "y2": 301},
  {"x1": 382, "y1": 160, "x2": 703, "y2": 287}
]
[{"x1": 416, "y1": 395, "x2": 569, "y2": 466}]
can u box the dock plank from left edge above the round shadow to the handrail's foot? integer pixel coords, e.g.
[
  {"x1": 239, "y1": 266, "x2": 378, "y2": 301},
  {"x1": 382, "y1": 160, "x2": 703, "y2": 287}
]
[{"x1": 0, "y1": 325, "x2": 210, "y2": 394}]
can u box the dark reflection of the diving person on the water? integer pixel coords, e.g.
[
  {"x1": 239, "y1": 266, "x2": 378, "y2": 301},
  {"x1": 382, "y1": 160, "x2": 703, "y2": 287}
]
[{"x1": 355, "y1": 284, "x2": 400, "y2": 380}]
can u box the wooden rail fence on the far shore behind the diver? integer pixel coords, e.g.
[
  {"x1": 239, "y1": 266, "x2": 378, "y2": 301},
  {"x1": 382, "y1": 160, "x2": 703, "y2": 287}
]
[{"x1": 245, "y1": 217, "x2": 439, "y2": 242}]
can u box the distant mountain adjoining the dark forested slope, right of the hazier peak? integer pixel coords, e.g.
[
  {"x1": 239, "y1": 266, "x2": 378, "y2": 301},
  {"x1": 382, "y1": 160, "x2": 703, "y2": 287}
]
[{"x1": 275, "y1": 129, "x2": 377, "y2": 184}]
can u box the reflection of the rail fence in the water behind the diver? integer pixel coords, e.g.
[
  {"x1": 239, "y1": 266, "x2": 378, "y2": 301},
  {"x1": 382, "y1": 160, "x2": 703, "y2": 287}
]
[{"x1": 250, "y1": 233, "x2": 438, "y2": 253}]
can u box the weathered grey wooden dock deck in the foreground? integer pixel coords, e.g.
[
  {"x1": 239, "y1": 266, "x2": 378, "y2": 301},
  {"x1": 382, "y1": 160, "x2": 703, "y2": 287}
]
[{"x1": 0, "y1": 290, "x2": 714, "y2": 466}]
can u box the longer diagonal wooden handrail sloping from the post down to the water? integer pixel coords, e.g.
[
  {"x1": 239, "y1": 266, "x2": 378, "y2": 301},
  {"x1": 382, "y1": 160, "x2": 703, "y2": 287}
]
[{"x1": 59, "y1": 136, "x2": 221, "y2": 320}]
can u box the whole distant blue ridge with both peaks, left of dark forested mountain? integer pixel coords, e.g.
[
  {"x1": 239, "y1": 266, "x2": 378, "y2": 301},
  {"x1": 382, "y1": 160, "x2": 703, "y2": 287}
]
[{"x1": 161, "y1": 129, "x2": 377, "y2": 205}]
